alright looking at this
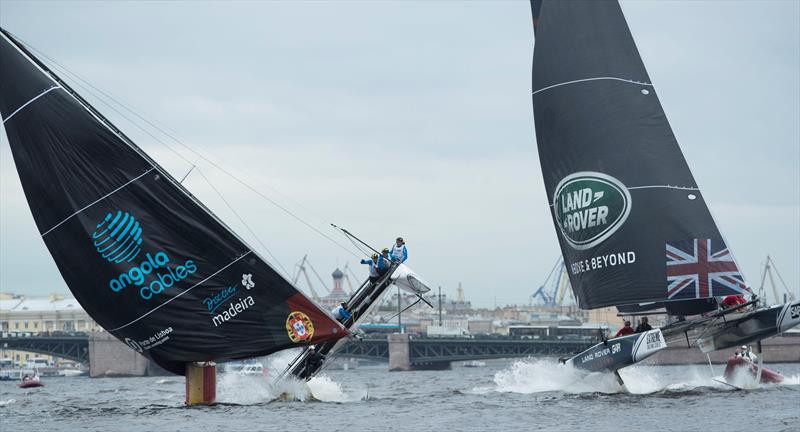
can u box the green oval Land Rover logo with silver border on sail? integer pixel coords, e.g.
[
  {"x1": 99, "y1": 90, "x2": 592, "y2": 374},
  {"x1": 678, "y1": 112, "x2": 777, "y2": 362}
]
[{"x1": 553, "y1": 171, "x2": 631, "y2": 250}]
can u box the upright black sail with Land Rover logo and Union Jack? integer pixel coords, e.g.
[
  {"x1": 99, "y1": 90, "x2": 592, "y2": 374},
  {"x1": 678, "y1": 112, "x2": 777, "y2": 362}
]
[{"x1": 532, "y1": 0, "x2": 747, "y2": 309}]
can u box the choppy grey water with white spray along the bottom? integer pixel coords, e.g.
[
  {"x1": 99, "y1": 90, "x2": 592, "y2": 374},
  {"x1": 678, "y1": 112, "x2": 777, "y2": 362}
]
[{"x1": 0, "y1": 359, "x2": 800, "y2": 432}]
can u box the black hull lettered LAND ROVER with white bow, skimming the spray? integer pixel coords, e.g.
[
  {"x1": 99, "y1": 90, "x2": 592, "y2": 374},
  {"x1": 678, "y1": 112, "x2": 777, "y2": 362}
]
[{"x1": 565, "y1": 329, "x2": 667, "y2": 372}]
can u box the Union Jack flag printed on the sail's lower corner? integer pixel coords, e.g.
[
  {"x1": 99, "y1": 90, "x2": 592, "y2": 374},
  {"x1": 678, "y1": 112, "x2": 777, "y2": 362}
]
[{"x1": 667, "y1": 239, "x2": 750, "y2": 300}]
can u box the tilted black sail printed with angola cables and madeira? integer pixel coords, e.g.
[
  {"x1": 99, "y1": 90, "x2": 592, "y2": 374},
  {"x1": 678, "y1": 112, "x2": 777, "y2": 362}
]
[{"x1": 0, "y1": 31, "x2": 346, "y2": 374}]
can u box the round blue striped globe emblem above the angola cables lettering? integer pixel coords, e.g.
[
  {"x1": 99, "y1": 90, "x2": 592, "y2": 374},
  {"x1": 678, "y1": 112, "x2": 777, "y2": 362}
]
[{"x1": 92, "y1": 211, "x2": 142, "y2": 264}]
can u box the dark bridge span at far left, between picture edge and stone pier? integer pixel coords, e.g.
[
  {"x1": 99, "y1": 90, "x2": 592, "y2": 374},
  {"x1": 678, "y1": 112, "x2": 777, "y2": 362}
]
[{"x1": 0, "y1": 334, "x2": 89, "y2": 364}]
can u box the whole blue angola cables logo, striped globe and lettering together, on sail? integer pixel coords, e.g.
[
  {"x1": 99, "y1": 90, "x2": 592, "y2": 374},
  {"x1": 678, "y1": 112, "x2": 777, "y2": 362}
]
[{"x1": 92, "y1": 210, "x2": 197, "y2": 300}]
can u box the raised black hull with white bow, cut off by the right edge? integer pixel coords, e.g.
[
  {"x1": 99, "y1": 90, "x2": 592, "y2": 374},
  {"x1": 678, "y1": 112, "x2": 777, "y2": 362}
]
[{"x1": 697, "y1": 301, "x2": 800, "y2": 353}]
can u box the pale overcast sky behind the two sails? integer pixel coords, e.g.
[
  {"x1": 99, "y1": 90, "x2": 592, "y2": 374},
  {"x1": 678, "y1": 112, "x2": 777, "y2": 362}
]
[{"x1": 0, "y1": 0, "x2": 800, "y2": 306}]
